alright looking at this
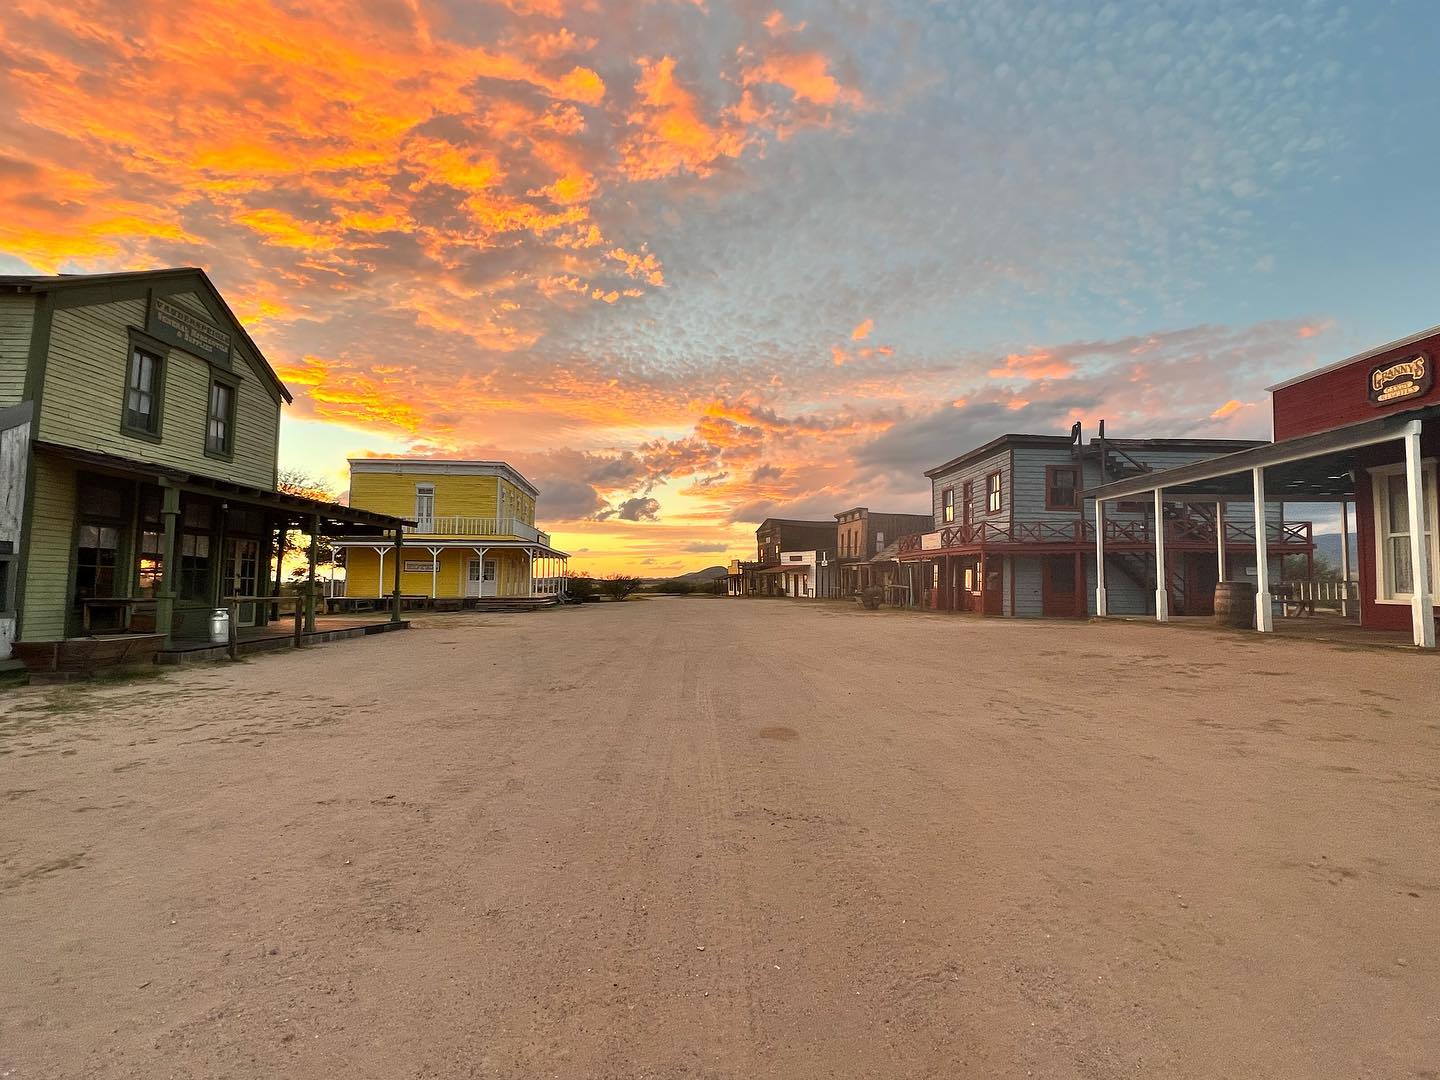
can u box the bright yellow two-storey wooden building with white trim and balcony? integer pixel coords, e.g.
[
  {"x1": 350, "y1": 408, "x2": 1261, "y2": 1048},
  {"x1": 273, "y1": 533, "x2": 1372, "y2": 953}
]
[{"x1": 336, "y1": 458, "x2": 569, "y2": 603}]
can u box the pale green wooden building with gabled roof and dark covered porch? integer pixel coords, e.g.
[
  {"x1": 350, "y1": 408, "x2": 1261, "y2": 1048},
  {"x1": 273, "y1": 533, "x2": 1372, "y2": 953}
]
[{"x1": 0, "y1": 268, "x2": 402, "y2": 667}]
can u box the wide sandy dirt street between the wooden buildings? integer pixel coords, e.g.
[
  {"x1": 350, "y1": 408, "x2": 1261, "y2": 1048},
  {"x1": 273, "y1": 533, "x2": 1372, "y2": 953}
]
[{"x1": 0, "y1": 599, "x2": 1440, "y2": 1080}]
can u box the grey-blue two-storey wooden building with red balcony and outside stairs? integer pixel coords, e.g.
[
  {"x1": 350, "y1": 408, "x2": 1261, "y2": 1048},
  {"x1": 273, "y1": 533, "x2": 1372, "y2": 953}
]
[{"x1": 897, "y1": 425, "x2": 1313, "y2": 618}]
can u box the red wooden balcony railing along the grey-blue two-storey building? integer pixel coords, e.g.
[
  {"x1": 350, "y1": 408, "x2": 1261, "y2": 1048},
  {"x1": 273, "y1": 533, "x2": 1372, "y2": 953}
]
[{"x1": 900, "y1": 518, "x2": 1315, "y2": 556}]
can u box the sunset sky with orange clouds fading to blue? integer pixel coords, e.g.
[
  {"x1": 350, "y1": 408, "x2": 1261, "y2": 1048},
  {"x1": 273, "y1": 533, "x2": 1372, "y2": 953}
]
[{"x1": 0, "y1": 0, "x2": 1440, "y2": 575}]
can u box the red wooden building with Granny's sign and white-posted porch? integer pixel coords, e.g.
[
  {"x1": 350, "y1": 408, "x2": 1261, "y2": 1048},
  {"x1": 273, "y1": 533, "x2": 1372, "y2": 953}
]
[{"x1": 1087, "y1": 327, "x2": 1440, "y2": 648}]
